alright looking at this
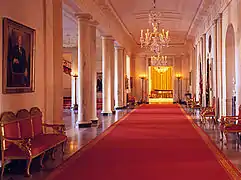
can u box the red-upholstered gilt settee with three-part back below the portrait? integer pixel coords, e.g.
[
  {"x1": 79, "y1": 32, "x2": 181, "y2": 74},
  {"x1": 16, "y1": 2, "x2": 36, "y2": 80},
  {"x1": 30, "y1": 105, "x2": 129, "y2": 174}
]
[{"x1": 0, "y1": 107, "x2": 67, "y2": 176}]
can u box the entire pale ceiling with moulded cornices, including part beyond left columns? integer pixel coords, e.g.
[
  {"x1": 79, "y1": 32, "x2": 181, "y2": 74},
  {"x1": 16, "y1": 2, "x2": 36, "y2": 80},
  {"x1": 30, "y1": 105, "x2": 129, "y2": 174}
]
[{"x1": 63, "y1": 0, "x2": 231, "y2": 53}]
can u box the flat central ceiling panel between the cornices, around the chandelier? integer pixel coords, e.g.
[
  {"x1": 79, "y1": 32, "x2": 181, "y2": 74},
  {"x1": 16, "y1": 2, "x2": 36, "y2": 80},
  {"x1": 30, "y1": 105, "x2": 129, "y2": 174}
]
[{"x1": 108, "y1": 0, "x2": 202, "y2": 44}]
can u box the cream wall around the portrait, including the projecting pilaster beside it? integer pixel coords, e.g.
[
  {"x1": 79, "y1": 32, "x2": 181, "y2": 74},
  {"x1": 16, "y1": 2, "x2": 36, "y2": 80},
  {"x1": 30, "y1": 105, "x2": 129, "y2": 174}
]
[{"x1": 0, "y1": 0, "x2": 63, "y2": 123}]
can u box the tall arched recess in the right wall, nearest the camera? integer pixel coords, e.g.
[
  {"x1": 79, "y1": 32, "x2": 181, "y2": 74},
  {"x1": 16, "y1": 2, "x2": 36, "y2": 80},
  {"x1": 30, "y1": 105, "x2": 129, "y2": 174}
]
[{"x1": 225, "y1": 24, "x2": 235, "y2": 115}]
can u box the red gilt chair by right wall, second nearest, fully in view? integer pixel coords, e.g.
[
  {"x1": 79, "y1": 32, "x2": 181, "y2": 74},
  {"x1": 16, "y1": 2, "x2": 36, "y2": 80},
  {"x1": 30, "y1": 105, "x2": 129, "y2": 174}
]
[{"x1": 200, "y1": 97, "x2": 216, "y2": 123}]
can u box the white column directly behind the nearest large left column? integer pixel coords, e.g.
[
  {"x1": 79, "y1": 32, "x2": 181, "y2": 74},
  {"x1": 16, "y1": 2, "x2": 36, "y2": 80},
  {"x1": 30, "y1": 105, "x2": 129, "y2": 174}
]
[{"x1": 90, "y1": 21, "x2": 98, "y2": 123}]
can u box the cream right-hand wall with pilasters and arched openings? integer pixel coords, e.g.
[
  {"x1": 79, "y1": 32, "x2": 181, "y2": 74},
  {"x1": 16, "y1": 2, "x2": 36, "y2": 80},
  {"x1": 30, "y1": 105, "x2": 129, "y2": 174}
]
[{"x1": 194, "y1": 0, "x2": 241, "y2": 115}]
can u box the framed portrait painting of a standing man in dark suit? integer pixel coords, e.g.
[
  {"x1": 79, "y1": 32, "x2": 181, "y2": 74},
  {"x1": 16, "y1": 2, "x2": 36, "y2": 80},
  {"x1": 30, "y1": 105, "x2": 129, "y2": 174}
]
[{"x1": 3, "y1": 18, "x2": 35, "y2": 93}]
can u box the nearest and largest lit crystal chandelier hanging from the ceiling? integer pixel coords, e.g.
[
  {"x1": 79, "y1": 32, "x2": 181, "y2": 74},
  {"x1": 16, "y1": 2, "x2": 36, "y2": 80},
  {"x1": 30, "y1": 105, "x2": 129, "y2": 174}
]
[{"x1": 140, "y1": 0, "x2": 170, "y2": 53}]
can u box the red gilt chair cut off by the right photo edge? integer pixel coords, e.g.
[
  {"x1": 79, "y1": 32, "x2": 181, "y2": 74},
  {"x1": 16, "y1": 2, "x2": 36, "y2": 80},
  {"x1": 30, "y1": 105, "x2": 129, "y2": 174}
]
[{"x1": 220, "y1": 105, "x2": 241, "y2": 143}]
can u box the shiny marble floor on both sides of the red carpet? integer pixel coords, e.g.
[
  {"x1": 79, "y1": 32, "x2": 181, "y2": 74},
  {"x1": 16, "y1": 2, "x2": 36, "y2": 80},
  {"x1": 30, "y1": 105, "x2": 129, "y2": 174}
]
[{"x1": 3, "y1": 107, "x2": 241, "y2": 180}]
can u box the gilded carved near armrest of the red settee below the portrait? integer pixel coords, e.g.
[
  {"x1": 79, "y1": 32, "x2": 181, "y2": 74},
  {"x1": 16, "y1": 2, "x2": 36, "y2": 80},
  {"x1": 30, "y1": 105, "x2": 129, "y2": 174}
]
[{"x1": 2, "y1": 136, "x2": 32, "y2": 157}]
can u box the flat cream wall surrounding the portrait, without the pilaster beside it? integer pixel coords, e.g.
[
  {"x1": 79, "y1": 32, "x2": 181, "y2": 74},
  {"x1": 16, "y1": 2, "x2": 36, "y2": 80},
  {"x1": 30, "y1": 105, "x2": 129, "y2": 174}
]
[{"x1": 0, "y1": 0, "x2": 45, "y2": 112}]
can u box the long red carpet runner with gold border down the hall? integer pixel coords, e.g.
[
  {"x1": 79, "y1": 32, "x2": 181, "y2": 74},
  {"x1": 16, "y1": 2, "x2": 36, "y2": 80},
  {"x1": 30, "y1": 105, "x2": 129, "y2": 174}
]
[{"x1": 48, "y1": 104, "x2": 240, "y2": 180}]
